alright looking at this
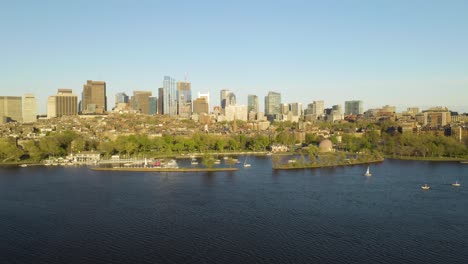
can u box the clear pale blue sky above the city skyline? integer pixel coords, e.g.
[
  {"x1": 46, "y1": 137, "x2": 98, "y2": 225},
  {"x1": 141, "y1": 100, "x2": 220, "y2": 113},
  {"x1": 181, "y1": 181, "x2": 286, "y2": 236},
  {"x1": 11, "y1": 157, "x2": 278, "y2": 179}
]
[{"x1": 0, "y1": 0, "x2": 468, "y2": 113}]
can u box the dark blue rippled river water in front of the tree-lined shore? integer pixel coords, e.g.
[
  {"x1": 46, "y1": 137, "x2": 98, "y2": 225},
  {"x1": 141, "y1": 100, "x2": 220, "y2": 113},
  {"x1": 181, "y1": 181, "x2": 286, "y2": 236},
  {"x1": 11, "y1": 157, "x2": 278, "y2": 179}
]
[{"x1": 0, "y1": 157, "x2": 468, "y2": 263}]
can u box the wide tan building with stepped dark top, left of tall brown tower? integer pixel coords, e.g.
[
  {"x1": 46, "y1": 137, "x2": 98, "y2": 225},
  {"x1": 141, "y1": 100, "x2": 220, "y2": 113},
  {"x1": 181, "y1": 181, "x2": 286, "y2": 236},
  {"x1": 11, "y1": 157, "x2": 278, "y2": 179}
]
[{"x1": 47, "y1": 89, "x2": 77, "y2": 118}]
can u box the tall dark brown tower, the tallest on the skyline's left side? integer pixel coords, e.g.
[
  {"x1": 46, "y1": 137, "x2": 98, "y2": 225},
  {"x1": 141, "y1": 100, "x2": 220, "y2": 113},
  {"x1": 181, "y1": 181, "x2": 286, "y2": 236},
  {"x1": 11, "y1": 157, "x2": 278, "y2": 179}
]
[{"x1": 80, "y1": 80, "x2": 107, "y2": 114}]
